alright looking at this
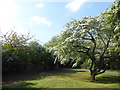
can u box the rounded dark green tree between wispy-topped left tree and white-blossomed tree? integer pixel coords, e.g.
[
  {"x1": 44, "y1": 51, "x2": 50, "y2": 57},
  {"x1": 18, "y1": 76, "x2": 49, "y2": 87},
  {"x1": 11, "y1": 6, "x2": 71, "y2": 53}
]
[{"x1": 28, "y1": 41, "x2": 54, "y2": 69}]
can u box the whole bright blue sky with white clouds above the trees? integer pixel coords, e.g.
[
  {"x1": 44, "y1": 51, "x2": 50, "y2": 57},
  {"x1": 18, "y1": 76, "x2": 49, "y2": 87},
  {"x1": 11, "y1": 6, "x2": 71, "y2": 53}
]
[{"x1": 0, "y1": 0, "x2": 113, "y2": 44}]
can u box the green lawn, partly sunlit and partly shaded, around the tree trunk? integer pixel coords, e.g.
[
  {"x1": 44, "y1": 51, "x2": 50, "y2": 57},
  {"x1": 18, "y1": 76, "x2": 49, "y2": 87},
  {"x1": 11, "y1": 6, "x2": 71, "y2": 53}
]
[{"x1": 3, "y1": 71, "x2": 120, "y2": 88}]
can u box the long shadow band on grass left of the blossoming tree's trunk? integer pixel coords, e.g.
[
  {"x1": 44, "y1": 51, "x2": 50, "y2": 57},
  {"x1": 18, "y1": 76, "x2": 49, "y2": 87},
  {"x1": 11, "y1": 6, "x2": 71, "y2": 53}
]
[{"x1": 3, "y1": 70, "x2": 86, "y2": 88}]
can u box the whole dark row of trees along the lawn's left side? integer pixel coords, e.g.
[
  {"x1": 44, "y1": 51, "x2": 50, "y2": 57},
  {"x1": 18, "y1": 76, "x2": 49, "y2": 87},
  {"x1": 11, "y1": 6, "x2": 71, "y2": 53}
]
[{"x1": 2, "y1": 31, "x2": 54, "y2": 74}]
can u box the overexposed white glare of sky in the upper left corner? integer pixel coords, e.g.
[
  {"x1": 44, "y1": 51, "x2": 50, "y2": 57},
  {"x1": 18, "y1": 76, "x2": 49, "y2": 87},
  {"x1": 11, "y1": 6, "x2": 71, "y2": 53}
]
[{"x1": 0, "y1": 0, "x2": 26, "y2": 34}]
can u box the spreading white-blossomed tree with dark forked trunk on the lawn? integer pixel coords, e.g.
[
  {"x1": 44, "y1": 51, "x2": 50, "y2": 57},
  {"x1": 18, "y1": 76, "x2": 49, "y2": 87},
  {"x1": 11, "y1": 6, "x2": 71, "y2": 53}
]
[{"x1": 58, "y1": 17, "x2": 112, "y2": 80}]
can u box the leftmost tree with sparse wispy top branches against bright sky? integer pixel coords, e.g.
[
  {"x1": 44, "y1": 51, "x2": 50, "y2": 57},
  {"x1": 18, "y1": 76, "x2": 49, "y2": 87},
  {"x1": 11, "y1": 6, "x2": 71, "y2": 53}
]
[{"x1": 2, "y1": 31, "x2": 30, "y2": 72}]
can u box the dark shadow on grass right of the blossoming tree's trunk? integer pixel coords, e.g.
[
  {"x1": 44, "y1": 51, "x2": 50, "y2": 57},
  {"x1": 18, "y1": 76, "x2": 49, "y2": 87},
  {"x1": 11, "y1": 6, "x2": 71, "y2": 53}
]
[{"x1": 94, "y1": 75, "x2": 120, "y2": 84}]
